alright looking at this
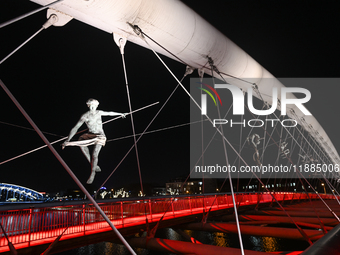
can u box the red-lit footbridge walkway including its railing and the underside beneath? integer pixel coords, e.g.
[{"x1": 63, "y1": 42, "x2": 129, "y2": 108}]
[{"x1": 0, "y1": 192, "x2": 335, "y2": 254}]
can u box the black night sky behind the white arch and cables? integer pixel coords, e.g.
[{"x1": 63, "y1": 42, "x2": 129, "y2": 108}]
[{"x1": 0, "y1": 0, "x2": 340, "y2": 191}]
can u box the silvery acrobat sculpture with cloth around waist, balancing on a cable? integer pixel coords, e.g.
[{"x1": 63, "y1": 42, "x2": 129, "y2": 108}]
[{"x1": 62, "y1": 98, "x2": 126, "y2": 184}]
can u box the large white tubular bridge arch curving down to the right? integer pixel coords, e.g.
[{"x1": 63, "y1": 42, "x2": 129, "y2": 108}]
[{"x1": 27, "y1": 0, "x2": 340, "y2": 164}]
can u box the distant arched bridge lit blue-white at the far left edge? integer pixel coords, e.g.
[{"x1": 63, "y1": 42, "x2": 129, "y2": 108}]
[{"x1": 0, "y1": 183, "x2": 44, "y2": 202}]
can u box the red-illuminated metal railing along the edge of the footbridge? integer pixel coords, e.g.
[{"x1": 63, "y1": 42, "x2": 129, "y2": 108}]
[{"x1": 0, "y1": 192, "x2": 334, "y2": 252}]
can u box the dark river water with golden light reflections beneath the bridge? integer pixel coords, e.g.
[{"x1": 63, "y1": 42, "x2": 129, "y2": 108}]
[{"x1": 58, "y1": 228, "x2": 309, "y2": 255}]
